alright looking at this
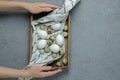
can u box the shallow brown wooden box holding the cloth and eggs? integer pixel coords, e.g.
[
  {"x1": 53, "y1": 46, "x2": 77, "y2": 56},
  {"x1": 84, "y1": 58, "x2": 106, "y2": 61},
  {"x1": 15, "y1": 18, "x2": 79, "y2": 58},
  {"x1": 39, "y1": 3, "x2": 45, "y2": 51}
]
[{"x1": 30, "y1": 13, "x2": 70, "y2": 69}]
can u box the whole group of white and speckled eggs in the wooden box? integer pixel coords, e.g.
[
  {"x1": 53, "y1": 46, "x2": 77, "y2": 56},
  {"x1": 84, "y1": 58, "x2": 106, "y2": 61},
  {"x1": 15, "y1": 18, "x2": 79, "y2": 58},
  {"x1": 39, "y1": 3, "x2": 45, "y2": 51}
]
[{"x1": 37, "y1": 23, "x2": 68, "y2": 66}]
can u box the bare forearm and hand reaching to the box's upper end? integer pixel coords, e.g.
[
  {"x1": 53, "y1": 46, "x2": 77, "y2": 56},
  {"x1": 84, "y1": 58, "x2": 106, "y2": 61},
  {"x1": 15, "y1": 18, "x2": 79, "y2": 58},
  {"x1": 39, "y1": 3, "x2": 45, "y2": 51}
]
[{"x1": 0, "y1": 0, "x2": 60, "y2": 14}]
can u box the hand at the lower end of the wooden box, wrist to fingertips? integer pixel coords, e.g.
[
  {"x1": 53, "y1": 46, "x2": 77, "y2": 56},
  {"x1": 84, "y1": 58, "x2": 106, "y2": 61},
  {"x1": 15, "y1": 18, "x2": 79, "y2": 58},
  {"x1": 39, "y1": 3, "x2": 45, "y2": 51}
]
[{"x1": 24, "y1": 66, "x2": 62, "y2": 78}]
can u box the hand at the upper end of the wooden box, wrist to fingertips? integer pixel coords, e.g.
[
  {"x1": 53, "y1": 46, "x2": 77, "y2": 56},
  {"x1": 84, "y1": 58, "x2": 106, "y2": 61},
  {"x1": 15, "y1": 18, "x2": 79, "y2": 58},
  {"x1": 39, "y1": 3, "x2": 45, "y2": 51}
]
[{"x1": 22, "y1": 2, "x2": 60, "y2": 14}]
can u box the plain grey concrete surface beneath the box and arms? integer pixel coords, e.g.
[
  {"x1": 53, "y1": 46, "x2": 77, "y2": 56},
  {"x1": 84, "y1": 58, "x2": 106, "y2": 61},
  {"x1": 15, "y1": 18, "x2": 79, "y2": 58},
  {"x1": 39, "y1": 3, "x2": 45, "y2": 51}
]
[{"x1": 0, "y1": 0, "x2": 120, "y2": 80}]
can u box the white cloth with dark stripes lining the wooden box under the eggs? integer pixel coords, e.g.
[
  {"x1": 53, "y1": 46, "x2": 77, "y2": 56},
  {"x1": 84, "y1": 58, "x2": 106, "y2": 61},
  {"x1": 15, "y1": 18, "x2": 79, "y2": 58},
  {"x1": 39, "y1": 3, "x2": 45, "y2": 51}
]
[{"x1": 19, "y1": 0, "x2": 80, "y2": 80}]
